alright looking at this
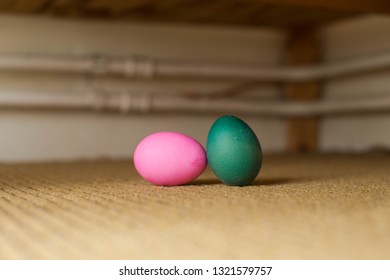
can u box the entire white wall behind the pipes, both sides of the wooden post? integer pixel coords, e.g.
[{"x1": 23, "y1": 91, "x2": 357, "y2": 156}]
[{"x1": 0, "y1": 16, "x2": 390, "y2": 162}]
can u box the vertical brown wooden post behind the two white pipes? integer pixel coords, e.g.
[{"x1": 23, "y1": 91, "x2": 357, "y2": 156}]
[{"x1": 284, "y1": 28, "x2": 321, "y2": 152}]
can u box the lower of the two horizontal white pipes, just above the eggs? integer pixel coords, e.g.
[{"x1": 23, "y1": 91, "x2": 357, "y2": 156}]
[{"x1": 0, "y1": 89, "x2": 390, "y2": 117}]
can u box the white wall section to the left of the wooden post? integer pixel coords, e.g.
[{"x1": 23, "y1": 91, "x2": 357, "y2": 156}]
[{"x1": 0, "y1": 16, "x2": 285, "y2": 162}]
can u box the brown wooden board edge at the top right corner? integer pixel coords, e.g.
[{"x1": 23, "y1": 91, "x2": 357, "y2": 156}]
[{"x1": 250, "y1": 0, "x2": 390, "y2": 14}]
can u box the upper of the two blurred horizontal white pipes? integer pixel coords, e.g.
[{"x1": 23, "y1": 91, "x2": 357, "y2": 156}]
[{"x1": 0, "y1": 53, "x2": 390, "y2": 82}]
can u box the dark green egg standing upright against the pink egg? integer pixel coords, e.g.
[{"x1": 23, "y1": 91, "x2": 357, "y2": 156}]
[{"x1": 206, "y1": 116, "x2": 262, "y2": 186}]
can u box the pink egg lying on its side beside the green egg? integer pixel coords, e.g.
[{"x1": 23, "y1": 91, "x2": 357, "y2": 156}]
[{"x1": 134, "y1": 132, "x2": 207, "y2": 186}]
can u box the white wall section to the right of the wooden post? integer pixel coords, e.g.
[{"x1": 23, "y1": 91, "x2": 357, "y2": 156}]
[{"x1": 320, "y1": 16, "x2": 390, "y2": 152}]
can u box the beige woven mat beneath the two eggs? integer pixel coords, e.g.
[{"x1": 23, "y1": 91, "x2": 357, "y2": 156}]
[{"x1": 0, "y1": 155, "x2": 390, "y2": 259}]
